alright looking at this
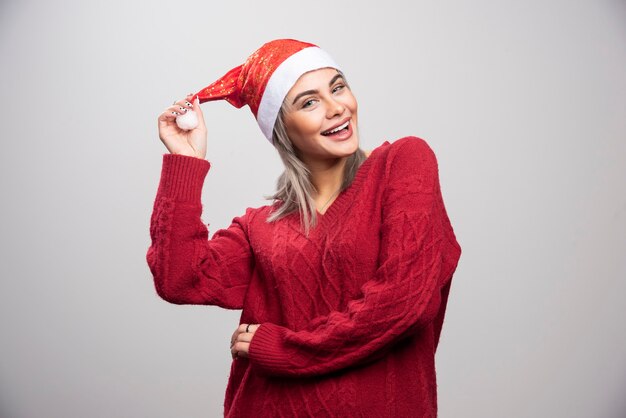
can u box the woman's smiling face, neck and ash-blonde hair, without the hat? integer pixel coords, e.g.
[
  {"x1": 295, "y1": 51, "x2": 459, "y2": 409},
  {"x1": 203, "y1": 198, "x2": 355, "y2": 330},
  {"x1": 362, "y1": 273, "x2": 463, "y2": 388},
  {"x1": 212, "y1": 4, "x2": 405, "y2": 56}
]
[{"x1": 268, "y1": 68, "x2": 366, "y2": 233}]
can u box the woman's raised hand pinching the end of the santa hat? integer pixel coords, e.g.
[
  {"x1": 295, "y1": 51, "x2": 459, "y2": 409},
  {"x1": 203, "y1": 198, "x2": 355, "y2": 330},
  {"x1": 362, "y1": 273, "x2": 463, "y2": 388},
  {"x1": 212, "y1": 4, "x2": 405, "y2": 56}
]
[{"x1": 159, "y1": 94, "x2": 207, "y2": 159}]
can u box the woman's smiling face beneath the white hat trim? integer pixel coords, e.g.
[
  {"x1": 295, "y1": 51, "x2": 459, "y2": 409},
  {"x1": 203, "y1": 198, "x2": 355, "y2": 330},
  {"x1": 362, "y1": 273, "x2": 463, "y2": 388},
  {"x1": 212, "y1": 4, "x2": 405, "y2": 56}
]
[{"x1": 284, "y1": 68, "x2": 359, "y2": 164}]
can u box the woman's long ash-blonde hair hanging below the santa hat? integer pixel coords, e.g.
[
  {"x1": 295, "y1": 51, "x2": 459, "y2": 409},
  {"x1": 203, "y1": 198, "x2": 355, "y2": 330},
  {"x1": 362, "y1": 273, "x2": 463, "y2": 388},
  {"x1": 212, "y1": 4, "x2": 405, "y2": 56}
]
[{"x1": 266, "y1": 74, "x2": 366, "y2": 235}]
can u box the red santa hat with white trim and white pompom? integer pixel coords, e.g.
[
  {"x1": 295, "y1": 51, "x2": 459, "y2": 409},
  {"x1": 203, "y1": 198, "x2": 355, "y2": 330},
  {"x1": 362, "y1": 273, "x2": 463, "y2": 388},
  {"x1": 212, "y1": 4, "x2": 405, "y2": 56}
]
[{"x1": 176, "y1": 39, "x2": 339, "y2": 142}]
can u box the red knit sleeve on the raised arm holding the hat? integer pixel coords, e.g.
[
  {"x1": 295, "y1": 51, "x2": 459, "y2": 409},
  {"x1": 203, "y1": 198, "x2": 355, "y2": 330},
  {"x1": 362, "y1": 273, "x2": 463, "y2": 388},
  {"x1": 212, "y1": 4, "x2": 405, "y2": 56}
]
[{"x1": 146, "y1": 154, "x2": 254, "y2": 309}]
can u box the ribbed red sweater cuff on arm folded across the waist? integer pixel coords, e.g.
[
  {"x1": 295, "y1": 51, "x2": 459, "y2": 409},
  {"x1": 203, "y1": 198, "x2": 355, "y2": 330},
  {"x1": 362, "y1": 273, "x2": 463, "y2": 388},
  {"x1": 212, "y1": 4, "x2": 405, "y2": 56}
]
[{"x1": 248, "y1": 322, "x2": 289, "y2": 374}]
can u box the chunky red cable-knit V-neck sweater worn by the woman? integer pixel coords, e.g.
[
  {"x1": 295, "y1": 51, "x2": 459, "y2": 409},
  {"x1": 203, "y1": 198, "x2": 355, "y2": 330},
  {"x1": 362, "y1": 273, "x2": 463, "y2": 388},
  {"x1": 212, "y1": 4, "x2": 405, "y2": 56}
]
[{"x1": 147, "y1": 137, "x2": 461, "y2": 418}]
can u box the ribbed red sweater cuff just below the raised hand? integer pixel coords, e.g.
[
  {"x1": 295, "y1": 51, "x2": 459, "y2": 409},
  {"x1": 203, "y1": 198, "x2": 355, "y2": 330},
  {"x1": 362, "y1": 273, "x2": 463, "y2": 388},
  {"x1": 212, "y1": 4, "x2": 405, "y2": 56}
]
[{"x1": 157, "y1": 154, "x2": 211, "y2": 203}]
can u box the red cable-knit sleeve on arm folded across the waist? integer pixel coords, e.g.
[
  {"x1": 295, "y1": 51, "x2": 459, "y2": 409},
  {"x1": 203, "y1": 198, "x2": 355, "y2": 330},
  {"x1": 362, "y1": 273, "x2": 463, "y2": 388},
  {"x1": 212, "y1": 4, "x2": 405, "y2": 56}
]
[{"x1": 249, "y1": 138, "x2": 460, "y2": 377}]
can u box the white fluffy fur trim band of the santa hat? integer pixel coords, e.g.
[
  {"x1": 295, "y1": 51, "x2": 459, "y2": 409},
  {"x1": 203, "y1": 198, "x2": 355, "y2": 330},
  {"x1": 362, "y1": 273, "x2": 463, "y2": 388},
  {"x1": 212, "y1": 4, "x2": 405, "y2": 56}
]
[{"x1": 257, "y1": 47, "x2": 340, "y2": 142}]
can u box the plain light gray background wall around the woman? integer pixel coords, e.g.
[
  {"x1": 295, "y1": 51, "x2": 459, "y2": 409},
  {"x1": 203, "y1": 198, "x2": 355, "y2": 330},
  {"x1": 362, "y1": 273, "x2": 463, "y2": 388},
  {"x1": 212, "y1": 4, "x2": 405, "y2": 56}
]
[{"x1": 0, "y1": 0, "x2": 626, "y2": 418}]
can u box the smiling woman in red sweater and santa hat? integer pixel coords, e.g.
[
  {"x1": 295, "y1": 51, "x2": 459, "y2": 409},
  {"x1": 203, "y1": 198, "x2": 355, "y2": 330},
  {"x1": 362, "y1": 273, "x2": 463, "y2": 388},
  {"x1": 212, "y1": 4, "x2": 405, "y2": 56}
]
[{"x1": 147, "y1": 39, "x2": 461, "y2": 418}]
